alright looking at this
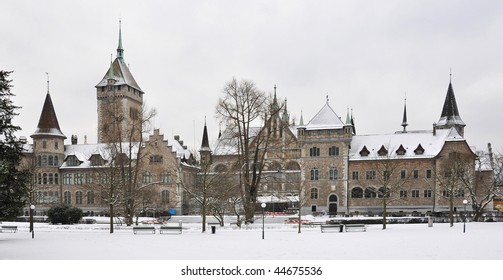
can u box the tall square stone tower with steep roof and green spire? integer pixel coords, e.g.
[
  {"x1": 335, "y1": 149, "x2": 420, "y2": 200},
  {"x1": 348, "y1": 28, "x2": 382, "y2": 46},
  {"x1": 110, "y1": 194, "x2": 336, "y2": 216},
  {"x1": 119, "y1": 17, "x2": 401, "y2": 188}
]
[{"x1": 96, "y1": 22, "x2": 144, "y2": 143}]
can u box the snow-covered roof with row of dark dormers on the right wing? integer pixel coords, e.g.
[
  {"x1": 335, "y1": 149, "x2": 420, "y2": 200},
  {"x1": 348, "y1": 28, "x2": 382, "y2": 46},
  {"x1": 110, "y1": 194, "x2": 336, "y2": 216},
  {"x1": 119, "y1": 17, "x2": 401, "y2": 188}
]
[{"x1": 349, "y1": 128, "x2": 464, "y2": 160}]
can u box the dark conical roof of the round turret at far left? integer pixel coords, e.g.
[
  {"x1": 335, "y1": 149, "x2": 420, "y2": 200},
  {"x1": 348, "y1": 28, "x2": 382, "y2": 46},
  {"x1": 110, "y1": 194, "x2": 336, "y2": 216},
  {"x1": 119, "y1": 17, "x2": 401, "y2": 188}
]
[{"x1": 31, "y1": 92, "x2": 66, "y2": 139}]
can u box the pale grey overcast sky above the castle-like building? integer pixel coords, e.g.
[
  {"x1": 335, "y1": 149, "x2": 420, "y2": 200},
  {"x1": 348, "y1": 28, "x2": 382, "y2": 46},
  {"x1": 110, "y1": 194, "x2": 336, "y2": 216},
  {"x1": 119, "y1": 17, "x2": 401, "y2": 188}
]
[{"x1": 0, "y1": 0, "x2": 503, "y2": 151}]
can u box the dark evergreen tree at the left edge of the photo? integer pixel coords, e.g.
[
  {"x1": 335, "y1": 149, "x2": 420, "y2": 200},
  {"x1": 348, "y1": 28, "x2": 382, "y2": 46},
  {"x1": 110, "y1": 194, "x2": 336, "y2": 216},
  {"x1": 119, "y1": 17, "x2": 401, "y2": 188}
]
[{"x1": 0, "y1": 70, "x2": 27, "y2": 221}]
